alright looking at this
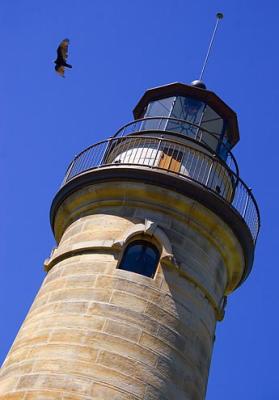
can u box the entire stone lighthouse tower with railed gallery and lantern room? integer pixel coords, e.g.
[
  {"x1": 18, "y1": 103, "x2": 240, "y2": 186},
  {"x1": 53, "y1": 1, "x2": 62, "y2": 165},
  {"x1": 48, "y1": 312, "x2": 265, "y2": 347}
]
[{"x1": 0, "y1": 81, "x2": 260, "y2": 400}]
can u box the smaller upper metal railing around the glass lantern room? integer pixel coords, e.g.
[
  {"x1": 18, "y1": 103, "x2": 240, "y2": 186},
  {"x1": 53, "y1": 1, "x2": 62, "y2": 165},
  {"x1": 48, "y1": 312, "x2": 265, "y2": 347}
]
[{"x1": 113, "y1": 117, "x2": 238, "y2": 173}]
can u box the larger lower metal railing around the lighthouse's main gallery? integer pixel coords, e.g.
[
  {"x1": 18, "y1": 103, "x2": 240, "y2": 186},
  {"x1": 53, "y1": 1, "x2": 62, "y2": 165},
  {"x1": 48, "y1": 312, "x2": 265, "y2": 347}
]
[{"x1": 62, "y1": 135, "x2": 260, "y2": 242}]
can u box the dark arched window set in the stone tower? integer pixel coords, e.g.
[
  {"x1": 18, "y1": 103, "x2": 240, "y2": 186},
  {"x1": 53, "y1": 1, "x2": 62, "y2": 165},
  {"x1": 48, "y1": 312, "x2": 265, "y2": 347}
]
[{"x1": 119, "y1": 240, "x2": 160, "y2": 278}]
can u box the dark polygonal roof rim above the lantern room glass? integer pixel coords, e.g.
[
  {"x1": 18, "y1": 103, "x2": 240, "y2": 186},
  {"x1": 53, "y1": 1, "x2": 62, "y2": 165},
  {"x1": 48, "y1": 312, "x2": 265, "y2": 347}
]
[{"x1": 133, "y1": 82, "x2": 239, "y2": 146}]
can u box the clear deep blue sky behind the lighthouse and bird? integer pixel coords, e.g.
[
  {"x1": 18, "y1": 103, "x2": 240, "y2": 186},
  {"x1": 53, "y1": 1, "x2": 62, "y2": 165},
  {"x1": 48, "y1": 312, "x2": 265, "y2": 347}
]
[{"x1": 0, "y1": 0, "x2": 279, "y2": 400}]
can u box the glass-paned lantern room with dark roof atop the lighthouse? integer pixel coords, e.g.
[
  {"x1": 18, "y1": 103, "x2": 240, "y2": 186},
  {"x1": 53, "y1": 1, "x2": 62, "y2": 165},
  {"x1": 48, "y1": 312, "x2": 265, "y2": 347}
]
[{"x1": 134, "y1": 81, "x2": 239, "y2": 160}]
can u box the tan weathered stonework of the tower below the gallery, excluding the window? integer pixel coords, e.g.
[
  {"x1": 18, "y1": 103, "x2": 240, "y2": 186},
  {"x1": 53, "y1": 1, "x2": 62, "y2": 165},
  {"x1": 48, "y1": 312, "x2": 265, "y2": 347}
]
[{"x1": 0, "y1": 182, "x2": 244, "y2": 400}]
